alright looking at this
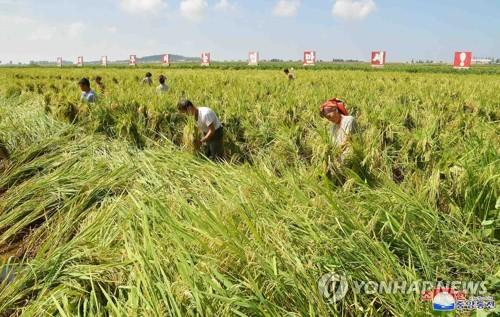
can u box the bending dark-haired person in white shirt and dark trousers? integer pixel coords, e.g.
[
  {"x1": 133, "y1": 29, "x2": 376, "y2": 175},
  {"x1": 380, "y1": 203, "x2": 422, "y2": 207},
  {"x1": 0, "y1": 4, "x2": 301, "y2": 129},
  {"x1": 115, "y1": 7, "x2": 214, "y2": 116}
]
[{"x1": 177, "y1": 100, "x2": 224, "y2": 161}]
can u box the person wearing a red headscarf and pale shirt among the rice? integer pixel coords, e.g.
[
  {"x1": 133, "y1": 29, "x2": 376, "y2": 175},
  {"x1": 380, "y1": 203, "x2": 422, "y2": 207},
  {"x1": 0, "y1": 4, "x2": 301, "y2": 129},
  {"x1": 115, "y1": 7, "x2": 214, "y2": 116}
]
[{"x1": 320, "y1": 98, "x2": 356, "y2": 150}]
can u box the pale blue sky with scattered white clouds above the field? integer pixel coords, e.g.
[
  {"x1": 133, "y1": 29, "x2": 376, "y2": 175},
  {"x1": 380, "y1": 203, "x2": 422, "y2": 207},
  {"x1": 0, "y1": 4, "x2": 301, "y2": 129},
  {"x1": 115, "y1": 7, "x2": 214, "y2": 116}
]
[{"x1": 0, "y1": 0, "x2": 500, "y2": 62}]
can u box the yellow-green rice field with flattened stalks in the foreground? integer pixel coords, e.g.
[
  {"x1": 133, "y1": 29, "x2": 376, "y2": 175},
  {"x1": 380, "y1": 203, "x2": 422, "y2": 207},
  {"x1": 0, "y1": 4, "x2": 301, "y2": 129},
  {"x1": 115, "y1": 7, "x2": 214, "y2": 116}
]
[{"x1": 0, "y1": 68, "x2": 500, "y2": 316}]
